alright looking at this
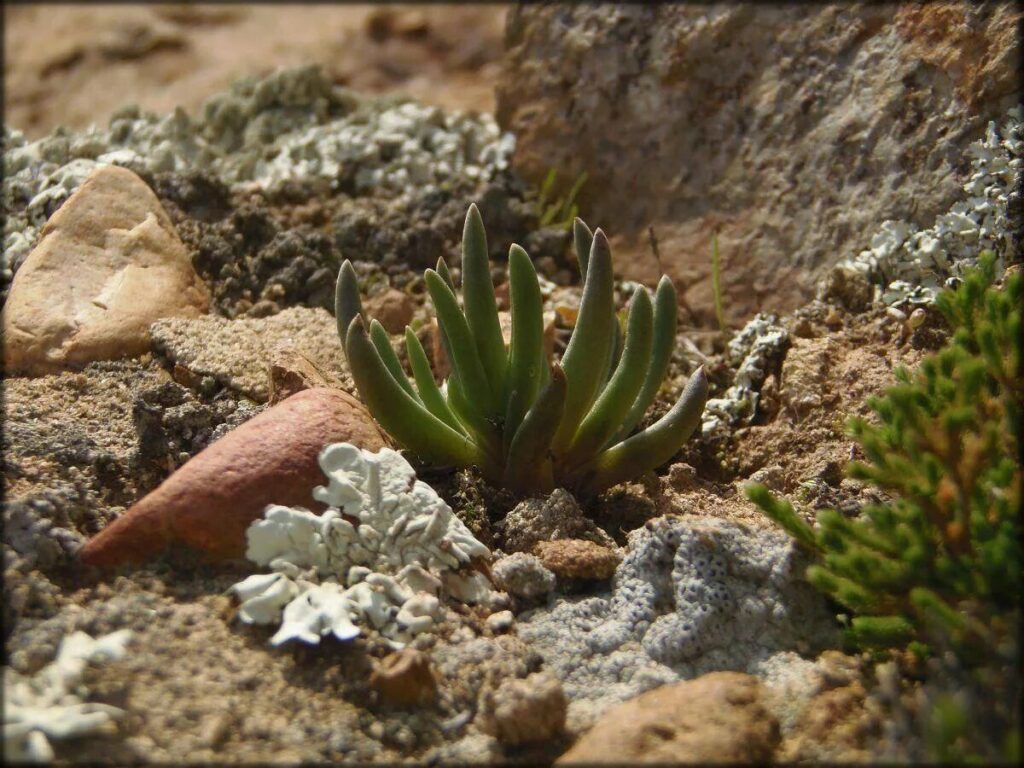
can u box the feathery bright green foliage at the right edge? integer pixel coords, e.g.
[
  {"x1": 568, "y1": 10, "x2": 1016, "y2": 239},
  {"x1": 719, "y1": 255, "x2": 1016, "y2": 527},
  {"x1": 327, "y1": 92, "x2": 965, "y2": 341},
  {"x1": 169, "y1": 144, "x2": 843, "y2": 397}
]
[{"x1": 748, "y1": 253, "x2": 1024, "y2": 666}]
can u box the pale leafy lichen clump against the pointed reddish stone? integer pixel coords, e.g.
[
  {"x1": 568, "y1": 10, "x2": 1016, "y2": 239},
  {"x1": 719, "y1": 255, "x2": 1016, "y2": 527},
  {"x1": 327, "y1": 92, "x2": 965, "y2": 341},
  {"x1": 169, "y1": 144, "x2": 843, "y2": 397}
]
[{"x1": 231, "y1": 442, "x2": 494, "y2": 647}]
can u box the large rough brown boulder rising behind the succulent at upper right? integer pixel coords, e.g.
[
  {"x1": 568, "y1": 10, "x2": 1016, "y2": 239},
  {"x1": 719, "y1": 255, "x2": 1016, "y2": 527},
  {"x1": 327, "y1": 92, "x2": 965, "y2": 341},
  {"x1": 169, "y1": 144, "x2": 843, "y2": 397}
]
[{"x1": 498, "y1": 2, "x2": 1021, "y2": 321}]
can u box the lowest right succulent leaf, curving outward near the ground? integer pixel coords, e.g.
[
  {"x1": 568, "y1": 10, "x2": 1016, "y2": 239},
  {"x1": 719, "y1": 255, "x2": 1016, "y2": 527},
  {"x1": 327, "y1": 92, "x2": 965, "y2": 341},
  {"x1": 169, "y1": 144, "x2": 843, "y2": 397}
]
[{"x1": 567, "y1": 367, "x2": 708, "y2": 494}]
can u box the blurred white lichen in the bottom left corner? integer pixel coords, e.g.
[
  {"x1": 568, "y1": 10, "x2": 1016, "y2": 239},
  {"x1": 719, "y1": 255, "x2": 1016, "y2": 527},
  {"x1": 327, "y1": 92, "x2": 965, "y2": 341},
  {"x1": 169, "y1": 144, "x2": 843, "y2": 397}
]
[{"x1": 3, "y1": 630, "x2": 131, "y2": 763}]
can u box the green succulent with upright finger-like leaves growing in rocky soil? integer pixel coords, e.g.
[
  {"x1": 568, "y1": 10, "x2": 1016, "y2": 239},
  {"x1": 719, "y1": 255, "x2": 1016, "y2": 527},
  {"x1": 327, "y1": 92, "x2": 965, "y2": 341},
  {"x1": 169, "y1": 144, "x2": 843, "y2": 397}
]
[{"x1": 335, "y1": 206, "x2": 708, "y2": 495}]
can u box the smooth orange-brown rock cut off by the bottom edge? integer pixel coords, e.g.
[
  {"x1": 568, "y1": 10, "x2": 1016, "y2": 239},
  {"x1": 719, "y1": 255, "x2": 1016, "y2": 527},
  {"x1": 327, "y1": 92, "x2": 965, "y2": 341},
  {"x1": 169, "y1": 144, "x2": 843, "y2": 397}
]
[{"x1": 556, "y1": 672, "x2": 779, "y2": 765}]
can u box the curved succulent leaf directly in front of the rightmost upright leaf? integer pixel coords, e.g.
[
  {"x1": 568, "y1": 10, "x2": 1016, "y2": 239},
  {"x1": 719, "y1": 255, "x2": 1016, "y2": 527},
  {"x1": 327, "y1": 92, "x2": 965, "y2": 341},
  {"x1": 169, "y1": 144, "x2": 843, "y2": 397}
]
[{"x1": 558, "y1": 287, "x2": 653, "y2": 470}]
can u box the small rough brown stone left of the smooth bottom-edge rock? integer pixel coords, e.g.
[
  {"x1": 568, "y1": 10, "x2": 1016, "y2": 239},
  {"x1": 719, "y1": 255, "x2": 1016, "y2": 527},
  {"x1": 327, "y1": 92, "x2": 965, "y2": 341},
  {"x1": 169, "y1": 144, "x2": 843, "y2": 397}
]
[{"x1": 481, "y1": 672, "x2": 568, "y2": 744}]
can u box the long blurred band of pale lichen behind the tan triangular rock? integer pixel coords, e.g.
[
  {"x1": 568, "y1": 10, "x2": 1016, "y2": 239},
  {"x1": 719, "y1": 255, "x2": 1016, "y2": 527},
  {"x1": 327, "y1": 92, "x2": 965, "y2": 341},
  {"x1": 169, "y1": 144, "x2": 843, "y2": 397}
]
[{"x1": 3, "y1": 67, "x2": 515, "y2": 280}]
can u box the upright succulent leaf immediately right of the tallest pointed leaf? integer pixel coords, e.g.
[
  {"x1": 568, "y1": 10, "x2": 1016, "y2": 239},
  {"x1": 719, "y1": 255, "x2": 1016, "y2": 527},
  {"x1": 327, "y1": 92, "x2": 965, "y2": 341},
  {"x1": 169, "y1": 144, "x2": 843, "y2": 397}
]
[{"x1": 504, "y1": 245, "x2": 546, "y2": 447}]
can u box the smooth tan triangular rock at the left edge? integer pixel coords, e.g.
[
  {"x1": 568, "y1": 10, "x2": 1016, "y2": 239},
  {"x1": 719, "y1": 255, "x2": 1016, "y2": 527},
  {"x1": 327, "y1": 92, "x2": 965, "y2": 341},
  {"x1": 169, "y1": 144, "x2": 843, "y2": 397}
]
[{"x1": 3, "y1": 166, "x2": 210, "y2": 374}]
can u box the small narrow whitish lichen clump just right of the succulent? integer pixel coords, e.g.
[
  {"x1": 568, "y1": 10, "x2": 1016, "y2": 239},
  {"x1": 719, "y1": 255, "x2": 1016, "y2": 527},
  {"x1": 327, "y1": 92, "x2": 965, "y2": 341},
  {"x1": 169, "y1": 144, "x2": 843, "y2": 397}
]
[{"x1": 700, "y1": 313, "x2": 790, "y2": 438}]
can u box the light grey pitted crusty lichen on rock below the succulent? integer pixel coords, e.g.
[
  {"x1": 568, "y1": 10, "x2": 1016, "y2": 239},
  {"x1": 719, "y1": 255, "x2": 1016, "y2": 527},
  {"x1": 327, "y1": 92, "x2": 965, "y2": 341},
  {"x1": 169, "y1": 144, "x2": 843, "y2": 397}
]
[{"x1": 517, "y1": 516, "x2": 835, "y2": 727}]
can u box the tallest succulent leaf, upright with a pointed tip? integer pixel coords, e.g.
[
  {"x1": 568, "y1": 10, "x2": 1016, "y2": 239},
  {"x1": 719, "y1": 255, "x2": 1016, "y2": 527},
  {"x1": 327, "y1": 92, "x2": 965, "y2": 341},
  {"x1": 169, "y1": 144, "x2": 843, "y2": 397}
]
[{"x1": 462, "y1": 205, "x2": 508, "y2": 400}]
